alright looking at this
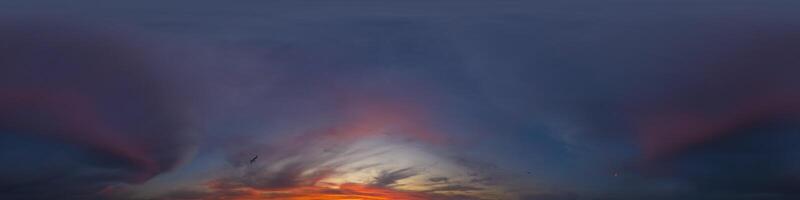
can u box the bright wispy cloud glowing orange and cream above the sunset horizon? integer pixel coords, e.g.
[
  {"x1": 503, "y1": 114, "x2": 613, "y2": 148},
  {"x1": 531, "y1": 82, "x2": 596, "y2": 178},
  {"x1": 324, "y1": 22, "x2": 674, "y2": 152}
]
[{"x1": 155, "y1": 98, "x2": 506, "y2": 199}]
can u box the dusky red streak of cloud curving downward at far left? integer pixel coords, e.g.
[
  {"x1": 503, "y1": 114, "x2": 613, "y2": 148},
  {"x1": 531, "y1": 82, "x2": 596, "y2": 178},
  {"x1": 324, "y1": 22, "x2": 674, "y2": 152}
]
[{"x1": 0, "y1": 89, "x2": 159, "y2": 183}]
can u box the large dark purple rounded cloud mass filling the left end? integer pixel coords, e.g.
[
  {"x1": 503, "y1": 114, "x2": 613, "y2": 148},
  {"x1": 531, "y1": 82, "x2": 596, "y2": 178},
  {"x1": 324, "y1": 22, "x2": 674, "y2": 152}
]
[{"x1": 0, "y1": 20, "x2": 192, "y2": 198}]
